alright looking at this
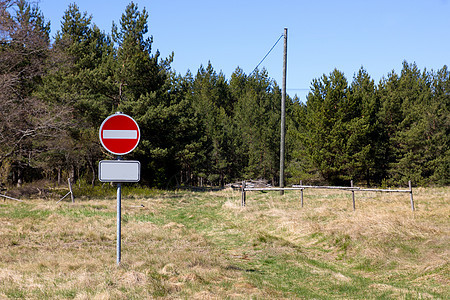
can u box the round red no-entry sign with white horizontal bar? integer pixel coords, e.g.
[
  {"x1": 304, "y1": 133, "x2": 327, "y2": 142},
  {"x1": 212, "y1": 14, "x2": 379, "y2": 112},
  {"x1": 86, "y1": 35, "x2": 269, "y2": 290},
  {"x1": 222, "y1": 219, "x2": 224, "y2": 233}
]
[{"x1": 99, "y1": 113, "x2": 141, "y2": 155}]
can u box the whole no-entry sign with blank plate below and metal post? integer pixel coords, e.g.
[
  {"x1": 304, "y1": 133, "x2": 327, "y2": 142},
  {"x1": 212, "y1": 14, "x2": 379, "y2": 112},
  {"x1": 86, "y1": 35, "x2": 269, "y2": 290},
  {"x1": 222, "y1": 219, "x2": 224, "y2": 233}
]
[{"x1": 98, "y1": 113, "x2": 141, "y2": 265}]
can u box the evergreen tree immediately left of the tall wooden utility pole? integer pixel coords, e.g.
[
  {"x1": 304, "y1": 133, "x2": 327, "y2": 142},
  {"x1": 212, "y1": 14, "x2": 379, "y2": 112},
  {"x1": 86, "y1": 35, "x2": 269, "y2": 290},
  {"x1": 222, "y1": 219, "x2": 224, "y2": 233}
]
[{"x1": 234, "y1": 70, "x2": 281, "y2": 183}]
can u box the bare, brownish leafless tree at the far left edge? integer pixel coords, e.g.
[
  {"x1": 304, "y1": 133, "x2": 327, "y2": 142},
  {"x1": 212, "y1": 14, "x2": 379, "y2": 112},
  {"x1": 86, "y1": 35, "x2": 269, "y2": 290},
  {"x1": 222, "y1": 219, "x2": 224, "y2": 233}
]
[{"x1": 0, "y1": 0, "x2": 69, "y2": 184}]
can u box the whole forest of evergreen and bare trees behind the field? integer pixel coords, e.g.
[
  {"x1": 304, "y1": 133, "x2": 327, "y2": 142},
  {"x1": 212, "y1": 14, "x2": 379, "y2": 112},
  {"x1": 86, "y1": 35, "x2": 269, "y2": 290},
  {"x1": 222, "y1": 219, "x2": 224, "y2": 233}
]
[{"x1": 0, "y1": 0, "x2": 450, "y2": 188}]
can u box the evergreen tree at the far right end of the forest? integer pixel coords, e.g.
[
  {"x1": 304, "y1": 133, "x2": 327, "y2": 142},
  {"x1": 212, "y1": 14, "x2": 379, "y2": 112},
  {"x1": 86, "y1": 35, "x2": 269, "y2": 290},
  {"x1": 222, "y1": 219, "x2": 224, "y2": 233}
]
[{"x1": 389, "y1": 62, "x2": 448, "y2": 185}]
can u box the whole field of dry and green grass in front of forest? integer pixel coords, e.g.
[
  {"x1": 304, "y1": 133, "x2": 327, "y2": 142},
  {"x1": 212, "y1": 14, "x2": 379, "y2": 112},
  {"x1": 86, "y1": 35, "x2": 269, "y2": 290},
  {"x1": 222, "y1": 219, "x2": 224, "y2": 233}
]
[{"x1": 0, "y1": 187, "x2": 450, "y2": 299}]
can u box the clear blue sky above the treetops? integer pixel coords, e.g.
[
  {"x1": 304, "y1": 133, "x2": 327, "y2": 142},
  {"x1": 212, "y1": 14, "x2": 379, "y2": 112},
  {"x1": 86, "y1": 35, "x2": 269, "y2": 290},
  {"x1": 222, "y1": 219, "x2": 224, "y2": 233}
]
[{"x1": 39, "y1": 0, "x2": 450, "y2": 101}]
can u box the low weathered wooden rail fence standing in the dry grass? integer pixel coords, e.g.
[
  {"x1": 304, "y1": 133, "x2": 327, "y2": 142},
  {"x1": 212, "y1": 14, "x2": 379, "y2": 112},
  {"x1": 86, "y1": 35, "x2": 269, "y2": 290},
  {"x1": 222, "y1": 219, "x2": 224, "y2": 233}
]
[{"x1": 241, "y1": 180, "x2": 415, "y2": 211}]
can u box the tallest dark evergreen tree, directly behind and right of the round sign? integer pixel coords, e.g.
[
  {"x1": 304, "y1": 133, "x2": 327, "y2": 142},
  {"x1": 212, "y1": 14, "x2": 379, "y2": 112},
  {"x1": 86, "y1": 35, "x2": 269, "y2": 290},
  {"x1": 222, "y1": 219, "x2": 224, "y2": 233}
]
[{"x1": 112, "y1": 2, "x2": 187, "y2": 188}]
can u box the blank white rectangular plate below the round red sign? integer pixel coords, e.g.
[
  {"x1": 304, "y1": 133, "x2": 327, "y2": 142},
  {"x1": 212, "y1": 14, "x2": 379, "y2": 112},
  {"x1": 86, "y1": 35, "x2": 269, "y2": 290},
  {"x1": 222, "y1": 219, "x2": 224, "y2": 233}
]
[{"x1": 98, "y1": 160, "x2": 141, "y2": 182}]
